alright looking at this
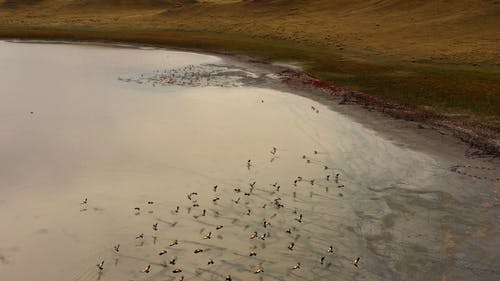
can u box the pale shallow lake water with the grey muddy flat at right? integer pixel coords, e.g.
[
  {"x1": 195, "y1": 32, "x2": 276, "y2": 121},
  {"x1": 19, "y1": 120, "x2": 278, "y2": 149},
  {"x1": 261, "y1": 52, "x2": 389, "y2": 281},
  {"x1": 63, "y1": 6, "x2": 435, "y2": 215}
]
[{"x1": 0, "y1": 42, "x2": 500, "y2": 281}]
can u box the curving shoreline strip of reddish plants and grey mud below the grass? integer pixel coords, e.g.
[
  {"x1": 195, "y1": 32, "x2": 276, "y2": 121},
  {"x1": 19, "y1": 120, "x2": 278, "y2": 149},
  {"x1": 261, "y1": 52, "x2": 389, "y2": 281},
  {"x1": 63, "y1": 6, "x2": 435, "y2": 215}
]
[{"x1": 0, "y1": 37, "x2": 500, "y2": 158}]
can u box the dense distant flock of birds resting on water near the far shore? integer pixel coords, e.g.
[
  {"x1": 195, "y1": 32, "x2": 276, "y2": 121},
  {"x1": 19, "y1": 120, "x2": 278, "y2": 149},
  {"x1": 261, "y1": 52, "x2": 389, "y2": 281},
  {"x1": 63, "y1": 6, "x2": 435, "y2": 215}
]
[{"x1": 118, "y1": 65, "x2": 256, "y2": 87}]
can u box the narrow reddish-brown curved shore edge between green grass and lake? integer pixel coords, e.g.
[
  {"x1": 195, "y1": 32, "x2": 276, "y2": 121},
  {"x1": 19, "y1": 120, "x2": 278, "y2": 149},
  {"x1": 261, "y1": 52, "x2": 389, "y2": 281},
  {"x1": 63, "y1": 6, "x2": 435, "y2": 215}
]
[{"x1": 0, "y1": 34, "x2": 500, "y2": 155}]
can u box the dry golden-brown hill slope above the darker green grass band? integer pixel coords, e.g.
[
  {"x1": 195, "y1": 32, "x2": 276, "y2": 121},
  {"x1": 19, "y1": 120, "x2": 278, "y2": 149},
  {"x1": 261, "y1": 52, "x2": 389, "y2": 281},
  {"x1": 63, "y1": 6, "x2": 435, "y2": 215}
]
[{"x1": 0, "y1": 0, "x2": 500, "y2": 64}]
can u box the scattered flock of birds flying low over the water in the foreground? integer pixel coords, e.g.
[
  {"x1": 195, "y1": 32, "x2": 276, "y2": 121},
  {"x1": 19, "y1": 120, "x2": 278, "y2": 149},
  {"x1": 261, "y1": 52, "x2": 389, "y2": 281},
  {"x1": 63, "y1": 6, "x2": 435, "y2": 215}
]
[{"x1": 80, "y1": 138, "x2": 360, "y2": 281}]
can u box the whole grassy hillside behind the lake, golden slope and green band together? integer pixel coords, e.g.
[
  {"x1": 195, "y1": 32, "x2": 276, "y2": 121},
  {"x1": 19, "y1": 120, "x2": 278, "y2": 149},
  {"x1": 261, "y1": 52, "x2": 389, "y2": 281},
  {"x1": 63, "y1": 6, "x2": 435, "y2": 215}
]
[{"x1": 0, "y1": 0, "x2": 500, "y2": 132}]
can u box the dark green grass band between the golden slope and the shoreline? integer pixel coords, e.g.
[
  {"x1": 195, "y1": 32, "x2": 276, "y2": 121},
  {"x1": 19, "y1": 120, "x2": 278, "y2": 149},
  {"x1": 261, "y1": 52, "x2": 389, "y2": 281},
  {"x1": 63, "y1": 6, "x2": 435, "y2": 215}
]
[{"x1": 0, "y1": 25, "x2": 500, "y2": 130}]
